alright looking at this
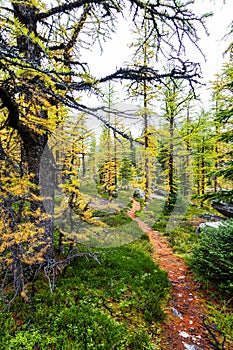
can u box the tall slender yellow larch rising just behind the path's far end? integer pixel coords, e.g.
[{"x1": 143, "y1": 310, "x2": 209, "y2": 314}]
[{"x1": 128, "y1": 8, "x2": 158, "y2": 202}]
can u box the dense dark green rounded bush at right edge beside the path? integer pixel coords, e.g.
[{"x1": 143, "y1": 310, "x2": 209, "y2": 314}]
[{"x1": 189, "y1": 220, "x2": 233, "y2": 294}]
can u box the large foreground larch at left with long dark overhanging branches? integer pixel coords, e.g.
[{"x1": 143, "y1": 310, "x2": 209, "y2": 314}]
[{"x1": 0, "y1": 0, "x2": 206, "y2": 295}]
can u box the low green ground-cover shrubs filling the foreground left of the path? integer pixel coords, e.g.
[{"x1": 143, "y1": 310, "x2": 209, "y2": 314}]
[{"x1": 0, "y1": 239, "x2": 169, "y2": 350}]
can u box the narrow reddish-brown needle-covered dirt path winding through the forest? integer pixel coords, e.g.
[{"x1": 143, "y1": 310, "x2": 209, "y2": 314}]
[{"x1": 128, "y1": 200, "x2": 233, "y2": 350}]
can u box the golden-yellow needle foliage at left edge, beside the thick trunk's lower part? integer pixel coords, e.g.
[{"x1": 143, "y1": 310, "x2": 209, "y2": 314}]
[{"x1": 0, "y1": 162, "x2": 48, "y2": 267}]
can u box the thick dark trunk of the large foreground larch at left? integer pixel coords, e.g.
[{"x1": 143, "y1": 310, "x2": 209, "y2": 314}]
[{"x1": 8, "y1": 2, "x2": 54, "y2": 260}]
